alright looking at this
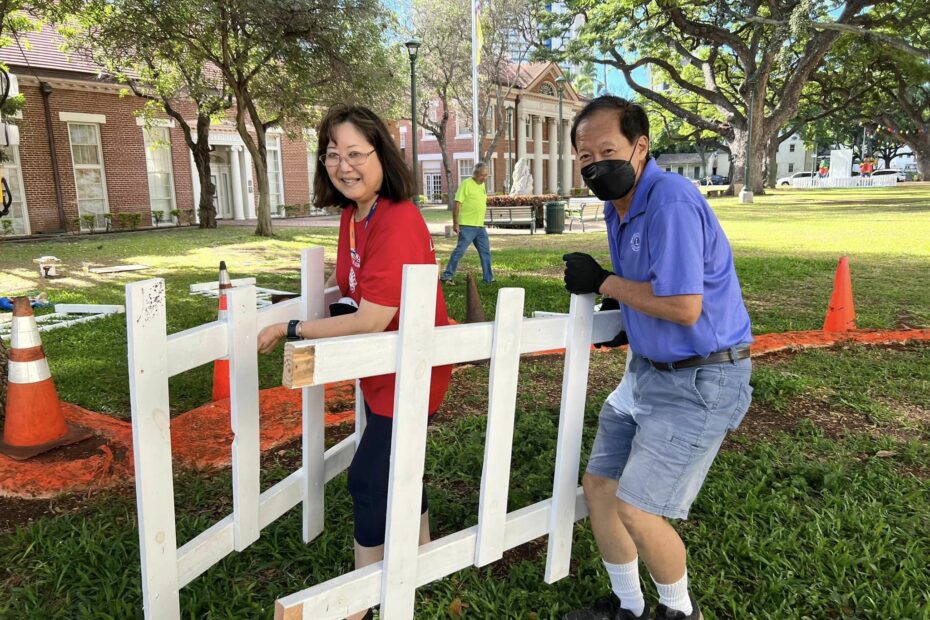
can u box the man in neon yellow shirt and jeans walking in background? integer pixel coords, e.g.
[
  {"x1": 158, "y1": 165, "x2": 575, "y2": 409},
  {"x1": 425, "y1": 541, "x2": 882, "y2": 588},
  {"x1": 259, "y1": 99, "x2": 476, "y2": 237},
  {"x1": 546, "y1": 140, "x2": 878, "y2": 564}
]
[{"x1": 439, "y1": 162, "x2": 494, "y2": 283}]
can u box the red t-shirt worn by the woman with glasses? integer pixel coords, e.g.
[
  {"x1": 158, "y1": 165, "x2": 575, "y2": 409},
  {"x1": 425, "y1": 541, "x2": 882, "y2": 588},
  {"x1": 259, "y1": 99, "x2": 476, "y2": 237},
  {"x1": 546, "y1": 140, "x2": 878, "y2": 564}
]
[{"x1": 336, "y1": 197, "x2": 452, "y2": 418}]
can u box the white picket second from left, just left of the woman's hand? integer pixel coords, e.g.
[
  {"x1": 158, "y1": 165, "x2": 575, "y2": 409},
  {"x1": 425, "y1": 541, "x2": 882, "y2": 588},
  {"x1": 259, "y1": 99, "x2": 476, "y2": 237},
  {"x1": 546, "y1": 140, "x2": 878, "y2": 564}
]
[{"x1": 227, "y1": 286, "x2": 261, "y2": 551}]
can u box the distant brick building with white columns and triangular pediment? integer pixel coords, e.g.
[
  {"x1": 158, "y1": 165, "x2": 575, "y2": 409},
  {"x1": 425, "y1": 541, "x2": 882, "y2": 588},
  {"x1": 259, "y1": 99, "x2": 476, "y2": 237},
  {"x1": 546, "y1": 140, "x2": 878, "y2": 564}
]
[{"x1": 398, "y1": 62, "x2": 585, "y2": 202}]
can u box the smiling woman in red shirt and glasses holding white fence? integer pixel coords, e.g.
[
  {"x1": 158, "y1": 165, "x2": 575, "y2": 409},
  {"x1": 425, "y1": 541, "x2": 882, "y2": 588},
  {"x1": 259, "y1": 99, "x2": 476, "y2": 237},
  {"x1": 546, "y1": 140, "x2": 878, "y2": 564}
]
[{"x1": 258, "y1": 105, "x2": 452, "y2": 618}]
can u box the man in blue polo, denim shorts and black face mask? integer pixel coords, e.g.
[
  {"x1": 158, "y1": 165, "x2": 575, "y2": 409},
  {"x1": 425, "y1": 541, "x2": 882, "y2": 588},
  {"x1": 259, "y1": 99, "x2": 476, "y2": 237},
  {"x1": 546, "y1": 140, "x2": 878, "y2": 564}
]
[{"x1": 563, "y1": 96, "x2": 752, "y2": 620}]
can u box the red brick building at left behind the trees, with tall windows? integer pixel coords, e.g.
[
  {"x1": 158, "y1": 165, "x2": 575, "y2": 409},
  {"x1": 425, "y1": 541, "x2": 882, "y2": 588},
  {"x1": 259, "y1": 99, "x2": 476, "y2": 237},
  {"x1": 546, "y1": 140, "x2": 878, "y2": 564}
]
[{"x1": 0, "y1": 27, "x2": 310, "y2": 235}]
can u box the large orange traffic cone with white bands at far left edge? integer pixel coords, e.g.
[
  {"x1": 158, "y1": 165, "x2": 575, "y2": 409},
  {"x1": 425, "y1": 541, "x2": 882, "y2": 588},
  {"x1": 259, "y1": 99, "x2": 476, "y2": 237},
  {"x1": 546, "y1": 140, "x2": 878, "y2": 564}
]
[{"x1": 0, "y1": 297, "x2": 93, "y2": 460}]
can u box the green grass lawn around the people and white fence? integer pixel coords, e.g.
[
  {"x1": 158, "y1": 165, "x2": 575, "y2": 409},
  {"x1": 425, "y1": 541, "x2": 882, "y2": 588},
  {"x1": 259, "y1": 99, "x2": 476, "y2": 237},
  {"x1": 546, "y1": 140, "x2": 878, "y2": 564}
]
[{"x1": 0, "y1": 185, "x2": 930, "y2": 620}]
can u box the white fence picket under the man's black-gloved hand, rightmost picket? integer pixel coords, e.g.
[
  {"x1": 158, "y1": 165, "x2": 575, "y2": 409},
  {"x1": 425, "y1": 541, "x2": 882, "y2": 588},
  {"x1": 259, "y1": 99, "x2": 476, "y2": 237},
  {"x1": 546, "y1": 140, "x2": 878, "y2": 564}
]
[{"x1": 545, "y1": 295, "x2": 594, "y2": 583}]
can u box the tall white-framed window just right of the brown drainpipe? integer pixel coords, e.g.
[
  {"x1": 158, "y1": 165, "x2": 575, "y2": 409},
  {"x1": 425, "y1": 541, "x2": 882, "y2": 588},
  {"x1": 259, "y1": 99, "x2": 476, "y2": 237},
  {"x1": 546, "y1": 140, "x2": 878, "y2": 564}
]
[{"x1": 68, "y1": 123, "x2": 110, "y2": 228}]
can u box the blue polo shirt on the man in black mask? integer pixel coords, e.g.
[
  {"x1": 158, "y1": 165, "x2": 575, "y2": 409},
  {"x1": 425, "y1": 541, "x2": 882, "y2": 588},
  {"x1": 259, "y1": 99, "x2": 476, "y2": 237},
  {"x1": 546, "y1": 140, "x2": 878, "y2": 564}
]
[{"x1": 604, "y1": 159, "x2": 752, "y2": 362}]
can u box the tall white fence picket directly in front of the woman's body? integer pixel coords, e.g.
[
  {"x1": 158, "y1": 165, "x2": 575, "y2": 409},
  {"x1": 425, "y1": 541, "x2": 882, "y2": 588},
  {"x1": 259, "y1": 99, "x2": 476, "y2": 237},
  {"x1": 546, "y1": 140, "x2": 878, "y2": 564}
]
[{"x1": 381, "y1": 265, "x2": 438, "y2": 620}]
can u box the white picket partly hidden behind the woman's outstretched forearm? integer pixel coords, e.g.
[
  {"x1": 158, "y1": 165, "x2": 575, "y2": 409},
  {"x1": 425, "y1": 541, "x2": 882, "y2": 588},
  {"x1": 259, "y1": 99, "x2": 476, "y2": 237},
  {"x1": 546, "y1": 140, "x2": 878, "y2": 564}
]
[{"x1": 300, "y1": 247, "x2": 326, "y2": 542}]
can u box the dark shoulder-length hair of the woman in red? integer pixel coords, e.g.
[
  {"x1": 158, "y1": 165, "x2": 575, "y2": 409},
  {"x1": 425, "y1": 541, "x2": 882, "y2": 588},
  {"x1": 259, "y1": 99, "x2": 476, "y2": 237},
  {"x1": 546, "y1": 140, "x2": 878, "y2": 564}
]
[{"x1": 313, "y1": 104, "x2": 414, "y2": 208}]
